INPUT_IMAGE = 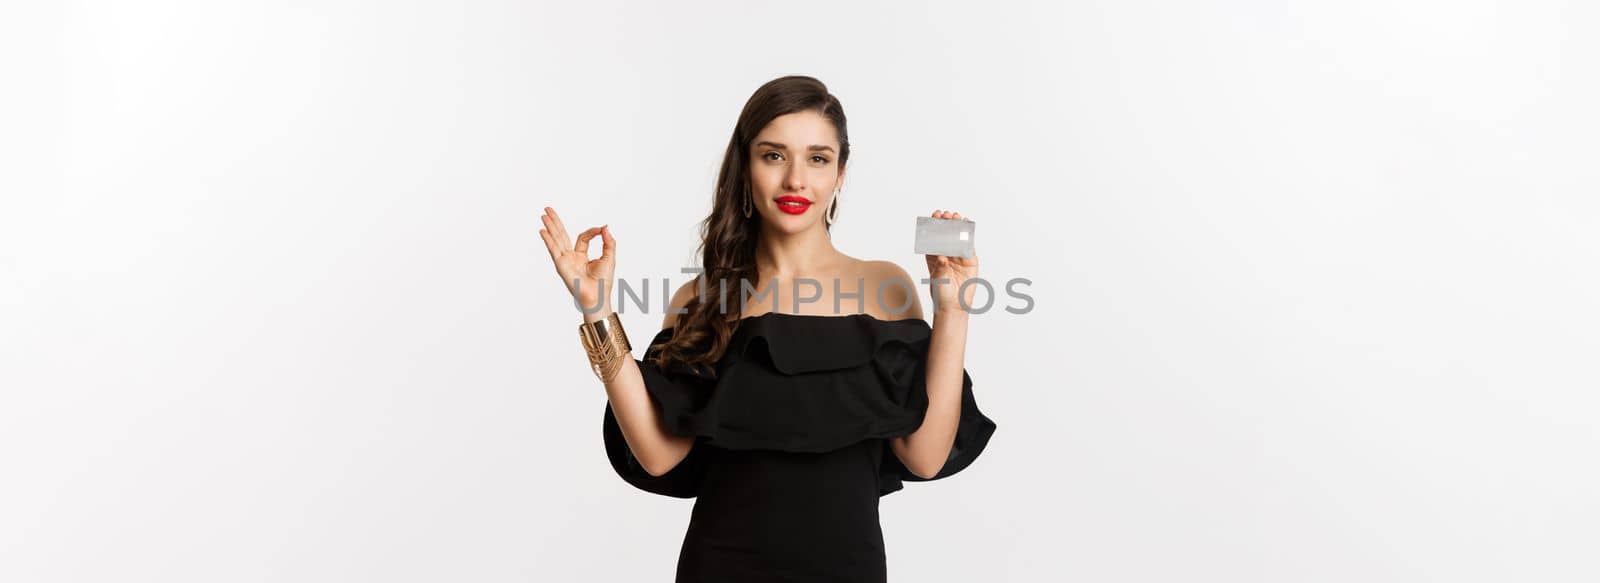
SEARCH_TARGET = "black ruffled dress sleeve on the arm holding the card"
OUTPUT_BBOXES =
[874,330,995,495]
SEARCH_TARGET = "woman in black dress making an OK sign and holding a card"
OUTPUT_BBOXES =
[539,77,995,583]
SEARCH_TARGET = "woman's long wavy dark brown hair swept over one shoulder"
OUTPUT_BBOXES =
[654,75,850,376]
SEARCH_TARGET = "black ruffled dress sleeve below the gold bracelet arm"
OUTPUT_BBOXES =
[602,328,714,498]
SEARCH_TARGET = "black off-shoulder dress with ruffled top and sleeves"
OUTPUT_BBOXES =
[603,312,995,583]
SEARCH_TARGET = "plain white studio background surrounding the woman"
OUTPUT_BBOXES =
[0,2,1600,581]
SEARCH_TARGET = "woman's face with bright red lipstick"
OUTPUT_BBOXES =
[749,111,845,232]
